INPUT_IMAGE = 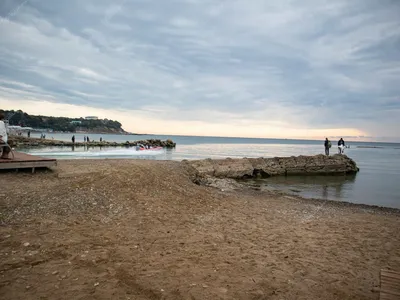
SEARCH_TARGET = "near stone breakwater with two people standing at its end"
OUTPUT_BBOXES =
[184,154,359,183]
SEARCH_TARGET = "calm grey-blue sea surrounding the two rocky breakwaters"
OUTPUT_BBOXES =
[21,134,400,208]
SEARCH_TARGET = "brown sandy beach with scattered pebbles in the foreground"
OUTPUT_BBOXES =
[0,160,400,300]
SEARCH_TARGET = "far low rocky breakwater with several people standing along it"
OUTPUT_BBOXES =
[10,136,176,149]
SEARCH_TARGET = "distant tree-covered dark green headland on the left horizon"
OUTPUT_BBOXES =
[5,110,126,133]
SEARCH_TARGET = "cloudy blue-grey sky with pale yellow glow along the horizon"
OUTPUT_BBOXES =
[0,0,400,140]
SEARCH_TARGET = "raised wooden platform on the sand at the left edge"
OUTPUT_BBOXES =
[0,151,57,173]
